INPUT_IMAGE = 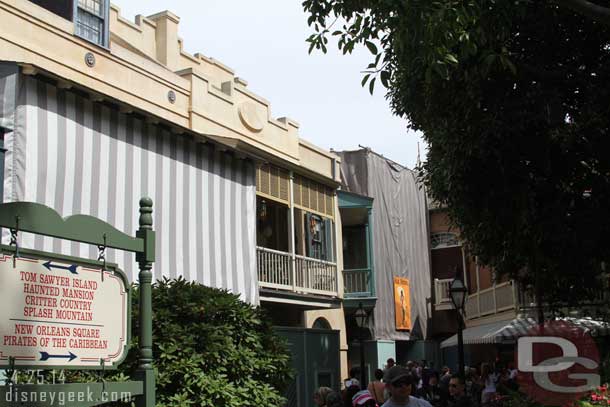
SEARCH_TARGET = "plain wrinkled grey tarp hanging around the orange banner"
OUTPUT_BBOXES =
[338,149,431,340]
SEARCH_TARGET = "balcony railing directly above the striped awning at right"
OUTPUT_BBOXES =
[466,281,516,319]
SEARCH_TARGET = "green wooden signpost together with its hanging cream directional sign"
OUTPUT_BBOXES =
[0,198,155,407]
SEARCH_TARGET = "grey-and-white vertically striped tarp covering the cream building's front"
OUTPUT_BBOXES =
[0,64,258,304]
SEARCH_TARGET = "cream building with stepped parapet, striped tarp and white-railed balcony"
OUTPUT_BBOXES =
[0,0,346,402]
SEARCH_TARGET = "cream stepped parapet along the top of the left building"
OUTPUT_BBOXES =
[0,0,339,183]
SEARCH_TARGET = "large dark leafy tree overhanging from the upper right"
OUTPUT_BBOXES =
[303,0,610,310]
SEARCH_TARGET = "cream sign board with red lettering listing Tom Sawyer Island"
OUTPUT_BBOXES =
[0,254,130,368]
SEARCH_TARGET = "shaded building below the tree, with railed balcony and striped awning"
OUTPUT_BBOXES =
[430,205,610,369]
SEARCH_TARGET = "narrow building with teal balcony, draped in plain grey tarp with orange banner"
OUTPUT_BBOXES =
[337,148,431,377]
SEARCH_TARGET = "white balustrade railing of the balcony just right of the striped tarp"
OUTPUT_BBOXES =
[256,247,338,297]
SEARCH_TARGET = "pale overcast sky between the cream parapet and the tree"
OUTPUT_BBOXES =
[113,0,425,168]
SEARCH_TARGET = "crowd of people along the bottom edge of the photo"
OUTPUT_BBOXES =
[314,358,518,407]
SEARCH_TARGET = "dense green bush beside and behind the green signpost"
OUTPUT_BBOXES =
[69,278,293,407]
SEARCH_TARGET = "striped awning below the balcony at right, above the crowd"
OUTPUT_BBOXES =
[441,318,610,348]
